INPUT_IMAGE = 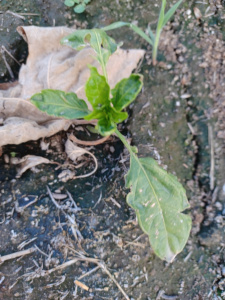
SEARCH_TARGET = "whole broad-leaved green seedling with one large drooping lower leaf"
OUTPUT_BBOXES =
[31,29,191,262]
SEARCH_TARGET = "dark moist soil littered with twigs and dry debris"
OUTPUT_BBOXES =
[0,0,225,300]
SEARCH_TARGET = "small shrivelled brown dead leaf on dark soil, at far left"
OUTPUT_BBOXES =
[11,155,55,178]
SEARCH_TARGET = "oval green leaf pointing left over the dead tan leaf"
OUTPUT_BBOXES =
[31,89,90,119]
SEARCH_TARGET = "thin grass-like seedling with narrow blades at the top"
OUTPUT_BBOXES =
[102,0,183,65]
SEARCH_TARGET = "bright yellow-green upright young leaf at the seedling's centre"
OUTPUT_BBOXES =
[85,67,110,108]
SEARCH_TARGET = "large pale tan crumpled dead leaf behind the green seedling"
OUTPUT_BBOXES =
[0,26,145,147]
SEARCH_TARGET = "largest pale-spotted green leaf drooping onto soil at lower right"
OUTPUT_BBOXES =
[126,156,191,262]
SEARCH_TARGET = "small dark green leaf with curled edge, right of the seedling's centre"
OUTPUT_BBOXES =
[111,74,143,111]
